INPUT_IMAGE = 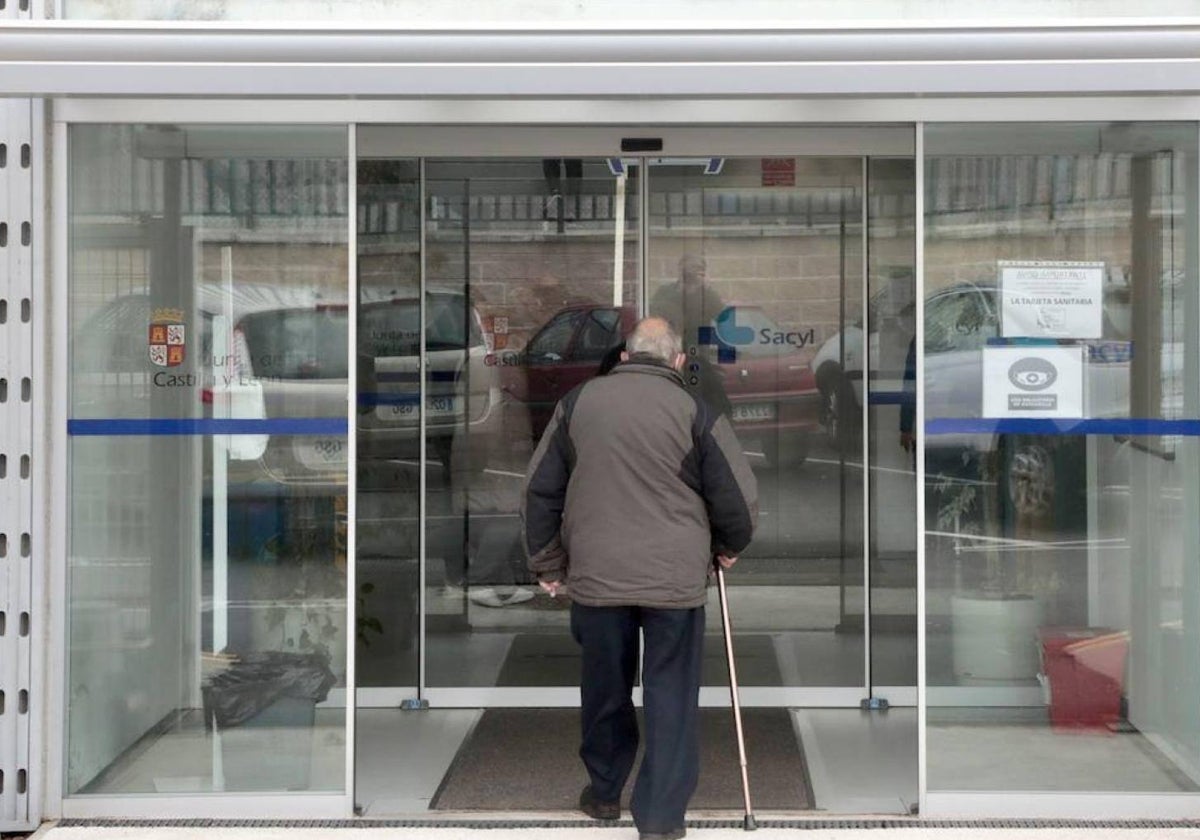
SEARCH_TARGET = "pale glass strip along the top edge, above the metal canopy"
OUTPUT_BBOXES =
[64,0,1195,25]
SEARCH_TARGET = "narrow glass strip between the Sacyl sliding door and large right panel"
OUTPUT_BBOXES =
[866,158,917,691]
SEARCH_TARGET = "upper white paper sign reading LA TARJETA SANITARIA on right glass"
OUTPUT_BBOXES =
[1000,260,1104,338]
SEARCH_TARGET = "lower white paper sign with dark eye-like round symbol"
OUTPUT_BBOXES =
[983,347,1084,418]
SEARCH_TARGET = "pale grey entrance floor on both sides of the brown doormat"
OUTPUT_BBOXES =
[72,708,1200,817]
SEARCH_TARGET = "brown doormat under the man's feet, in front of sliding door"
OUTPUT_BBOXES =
[430,708,812,814]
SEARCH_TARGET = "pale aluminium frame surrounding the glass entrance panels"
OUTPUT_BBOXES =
[49,98,1200,818]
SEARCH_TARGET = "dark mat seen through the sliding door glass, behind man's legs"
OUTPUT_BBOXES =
[496,630,782,686]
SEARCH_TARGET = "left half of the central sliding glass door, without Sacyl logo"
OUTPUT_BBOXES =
[358,158,641,706]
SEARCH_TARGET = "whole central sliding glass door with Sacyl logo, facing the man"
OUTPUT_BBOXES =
[358,132,916,706]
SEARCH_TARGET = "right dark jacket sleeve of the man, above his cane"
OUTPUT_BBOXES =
[697,412,758,556]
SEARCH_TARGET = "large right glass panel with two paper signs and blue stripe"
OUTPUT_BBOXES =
[924,124,1200,792]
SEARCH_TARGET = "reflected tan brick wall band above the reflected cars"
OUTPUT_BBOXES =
[208,219,1132,349]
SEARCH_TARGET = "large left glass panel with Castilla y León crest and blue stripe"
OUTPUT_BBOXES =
[66,126,348,794]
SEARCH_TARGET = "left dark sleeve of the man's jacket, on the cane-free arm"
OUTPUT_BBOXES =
[521,394,575,581]
